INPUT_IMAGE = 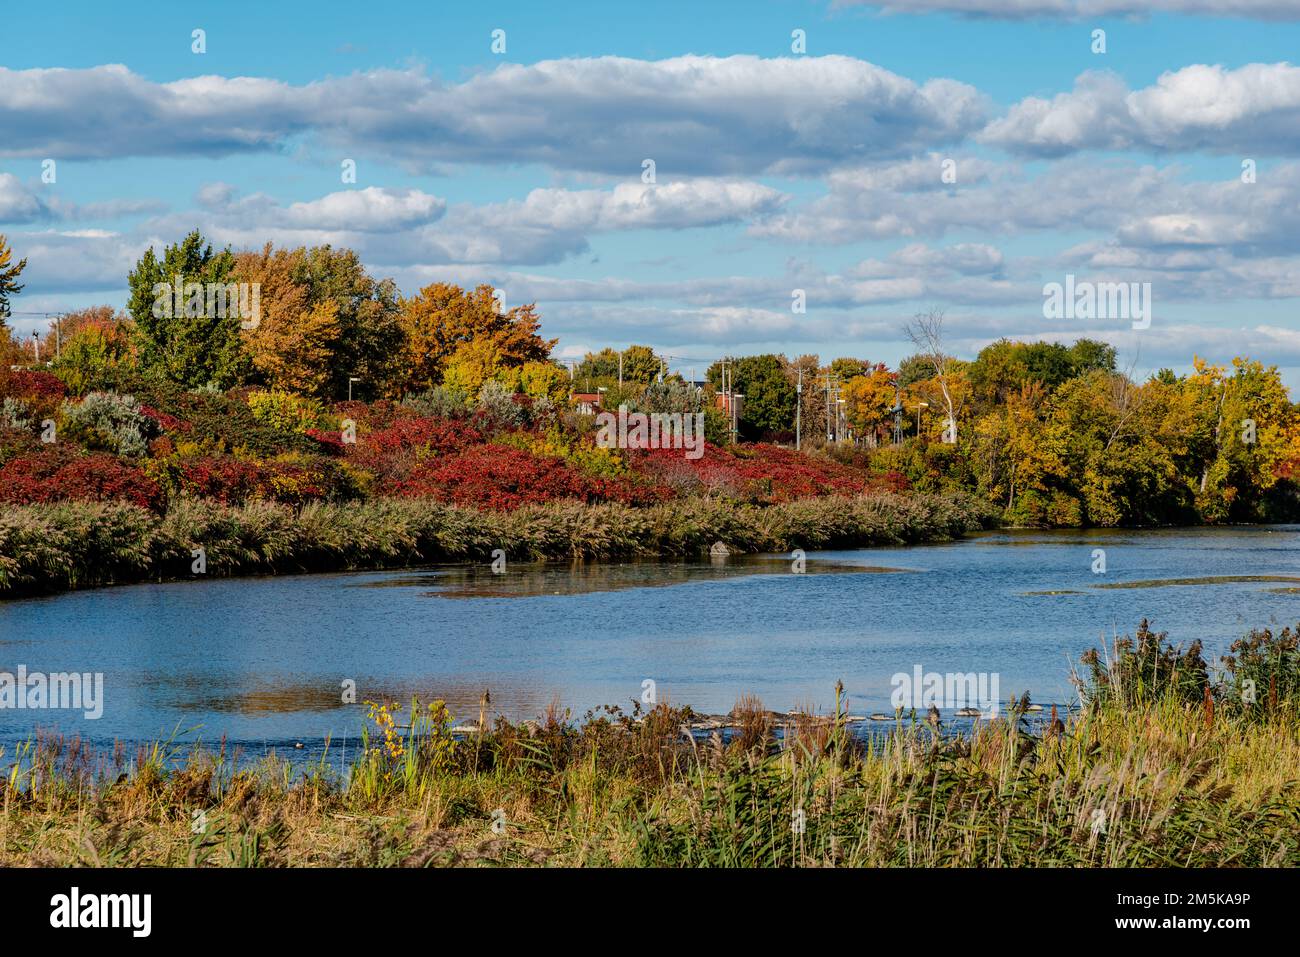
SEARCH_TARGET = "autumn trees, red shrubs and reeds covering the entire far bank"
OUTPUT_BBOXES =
[0,231,1300,594]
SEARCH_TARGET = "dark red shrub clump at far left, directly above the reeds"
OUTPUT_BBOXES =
[0,450,164,510]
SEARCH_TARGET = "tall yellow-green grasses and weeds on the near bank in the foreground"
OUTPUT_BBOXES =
[0,622,1300,867]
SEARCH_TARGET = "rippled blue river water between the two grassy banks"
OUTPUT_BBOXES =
[0,525,1300,752]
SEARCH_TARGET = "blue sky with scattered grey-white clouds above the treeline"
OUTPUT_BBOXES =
[0,0,1300,386]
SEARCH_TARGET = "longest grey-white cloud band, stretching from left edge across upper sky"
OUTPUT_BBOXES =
[0,56,987,177]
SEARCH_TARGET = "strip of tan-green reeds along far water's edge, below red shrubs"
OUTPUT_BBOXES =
[0,494,993,597]
